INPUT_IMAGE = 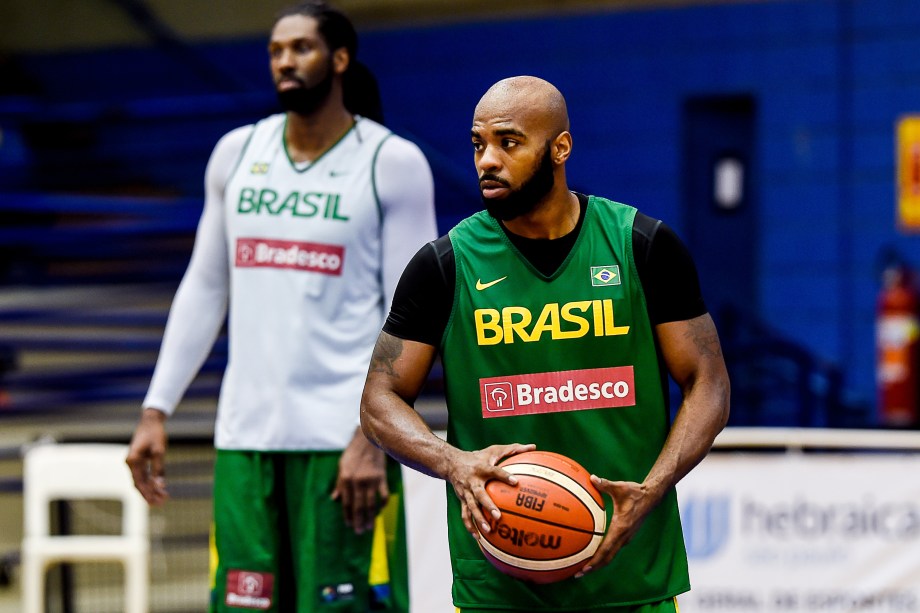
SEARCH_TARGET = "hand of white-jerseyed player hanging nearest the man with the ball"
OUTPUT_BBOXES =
[332,429,390,534]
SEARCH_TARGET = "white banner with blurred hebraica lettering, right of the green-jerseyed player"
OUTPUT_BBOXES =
[677,453,920,613]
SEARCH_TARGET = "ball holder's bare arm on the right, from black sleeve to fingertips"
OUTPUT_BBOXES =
[585,314,729,572]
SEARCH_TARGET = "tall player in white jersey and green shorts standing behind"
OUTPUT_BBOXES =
[128,2,437,613]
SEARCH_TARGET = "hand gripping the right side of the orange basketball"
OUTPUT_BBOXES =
[575,475,658,577]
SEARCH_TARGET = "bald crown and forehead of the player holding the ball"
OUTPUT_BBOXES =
[473,76,569,139]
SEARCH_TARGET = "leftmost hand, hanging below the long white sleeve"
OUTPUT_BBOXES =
[125,409,169,505]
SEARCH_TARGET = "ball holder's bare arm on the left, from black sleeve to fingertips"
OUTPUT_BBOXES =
[361,332,533,537]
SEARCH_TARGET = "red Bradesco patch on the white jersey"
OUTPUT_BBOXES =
[236,238,345,276]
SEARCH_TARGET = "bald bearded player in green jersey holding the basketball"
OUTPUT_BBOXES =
[361,77,729,613]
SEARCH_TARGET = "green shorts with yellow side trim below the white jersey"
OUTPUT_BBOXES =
[210,450,409,613]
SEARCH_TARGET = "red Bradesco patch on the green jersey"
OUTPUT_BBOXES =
[479,366,636,417]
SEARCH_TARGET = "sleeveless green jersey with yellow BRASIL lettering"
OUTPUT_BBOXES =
[441,196,690,611]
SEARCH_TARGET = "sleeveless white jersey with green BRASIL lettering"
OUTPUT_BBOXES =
[215,114,398,450]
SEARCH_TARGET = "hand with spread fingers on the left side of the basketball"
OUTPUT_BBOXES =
[447,443,537,539]
